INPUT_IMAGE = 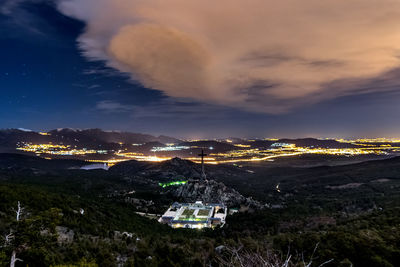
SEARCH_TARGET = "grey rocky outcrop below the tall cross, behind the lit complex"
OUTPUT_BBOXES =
[169,180,262,208]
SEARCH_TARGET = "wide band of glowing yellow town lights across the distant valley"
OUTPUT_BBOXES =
[16,138,400,166]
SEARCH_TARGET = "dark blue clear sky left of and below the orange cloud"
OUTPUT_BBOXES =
[0,2,400,138]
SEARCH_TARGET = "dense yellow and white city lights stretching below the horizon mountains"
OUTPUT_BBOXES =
[17,138,400,165]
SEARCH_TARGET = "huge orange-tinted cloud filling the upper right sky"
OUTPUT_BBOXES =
[58,0,400,113]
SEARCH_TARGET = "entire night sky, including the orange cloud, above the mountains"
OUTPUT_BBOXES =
[0,0,400,138]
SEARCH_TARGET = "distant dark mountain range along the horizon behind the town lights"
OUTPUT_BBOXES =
[0,128,354,150]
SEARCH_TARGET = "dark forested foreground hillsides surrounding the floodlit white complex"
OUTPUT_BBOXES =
[0,154,400,267]
